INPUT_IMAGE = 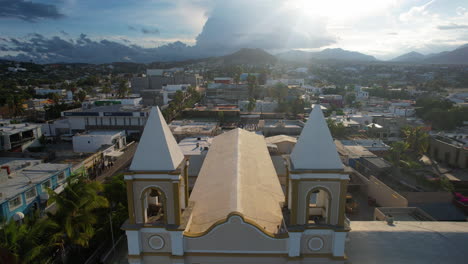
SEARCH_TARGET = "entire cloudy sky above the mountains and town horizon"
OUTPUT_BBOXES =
[0,0,468,61]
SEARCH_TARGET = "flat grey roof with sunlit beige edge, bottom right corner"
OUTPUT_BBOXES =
[345,221,468,264]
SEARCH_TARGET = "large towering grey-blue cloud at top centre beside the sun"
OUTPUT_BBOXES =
[196,0,336,53]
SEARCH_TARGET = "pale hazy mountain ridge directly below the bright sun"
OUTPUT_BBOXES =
[276,48,377,62]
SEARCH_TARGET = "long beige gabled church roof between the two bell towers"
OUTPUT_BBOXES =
[185,129,284,234]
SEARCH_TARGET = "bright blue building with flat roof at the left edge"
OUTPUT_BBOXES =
[0,158,71,220]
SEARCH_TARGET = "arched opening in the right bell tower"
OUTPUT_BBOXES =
[307,188,331,224]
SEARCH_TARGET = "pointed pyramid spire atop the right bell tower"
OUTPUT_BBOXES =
[291,104,343,170]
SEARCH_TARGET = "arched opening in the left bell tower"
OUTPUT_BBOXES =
[142,187,167,225]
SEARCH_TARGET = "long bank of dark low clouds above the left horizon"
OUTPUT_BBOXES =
[0,33,199,63]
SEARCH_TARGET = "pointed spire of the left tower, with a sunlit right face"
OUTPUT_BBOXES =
[130,107,184,171]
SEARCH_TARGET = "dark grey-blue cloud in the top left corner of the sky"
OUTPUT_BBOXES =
[0,0,64,22]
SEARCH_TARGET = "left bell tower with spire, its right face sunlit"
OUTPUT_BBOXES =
[125,107,188,227]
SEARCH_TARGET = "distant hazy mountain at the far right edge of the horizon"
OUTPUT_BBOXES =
[391,44,468,64]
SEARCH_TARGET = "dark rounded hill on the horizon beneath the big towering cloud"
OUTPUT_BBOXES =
[215,48,278,65]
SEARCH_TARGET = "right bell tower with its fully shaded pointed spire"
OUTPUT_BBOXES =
[287,104,349,257]
